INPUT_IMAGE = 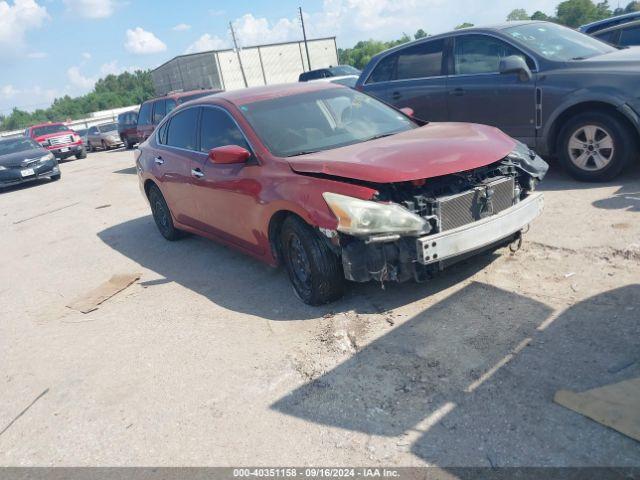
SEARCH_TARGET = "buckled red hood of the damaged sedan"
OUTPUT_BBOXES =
[287,123,516,183]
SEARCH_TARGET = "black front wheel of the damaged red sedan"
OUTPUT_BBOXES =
[280,216,345,306]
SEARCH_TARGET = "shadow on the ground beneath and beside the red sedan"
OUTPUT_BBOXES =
[98,216,497,320]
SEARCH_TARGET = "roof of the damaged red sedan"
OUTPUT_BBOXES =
[197,82,347,105]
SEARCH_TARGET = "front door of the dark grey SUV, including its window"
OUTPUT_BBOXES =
[447,34,536,142]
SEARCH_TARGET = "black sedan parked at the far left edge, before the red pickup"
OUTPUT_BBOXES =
[0,137,61,188]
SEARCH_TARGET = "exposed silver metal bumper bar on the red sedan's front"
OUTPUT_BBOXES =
[417,193,544,265]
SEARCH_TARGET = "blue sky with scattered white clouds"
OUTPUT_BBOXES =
[0,0,559,114]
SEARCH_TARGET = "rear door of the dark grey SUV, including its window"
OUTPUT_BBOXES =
[364,39,448,121]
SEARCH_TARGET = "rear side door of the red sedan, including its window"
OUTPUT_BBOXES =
[153,107,200,228]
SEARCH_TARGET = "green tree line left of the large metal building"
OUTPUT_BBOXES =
[0,70,154,131]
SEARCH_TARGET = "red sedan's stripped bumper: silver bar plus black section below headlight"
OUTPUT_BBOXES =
[341,193,544,282]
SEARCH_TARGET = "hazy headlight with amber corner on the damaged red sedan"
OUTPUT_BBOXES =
[322,192,427,235]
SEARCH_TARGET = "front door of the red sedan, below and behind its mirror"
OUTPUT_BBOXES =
[192,105,263,253]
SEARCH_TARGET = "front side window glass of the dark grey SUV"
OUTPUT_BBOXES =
[453,35,535,75]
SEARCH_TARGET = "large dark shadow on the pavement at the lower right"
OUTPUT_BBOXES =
[272,283,640,467]
